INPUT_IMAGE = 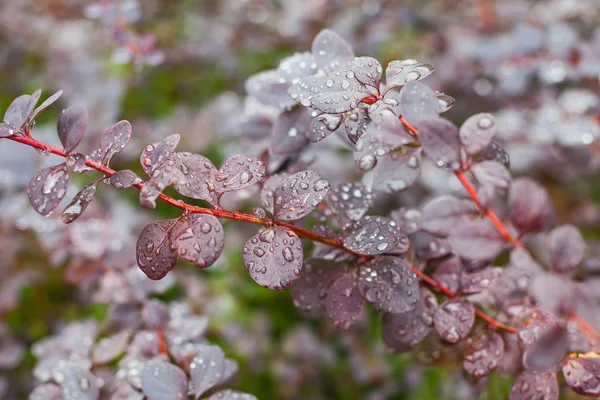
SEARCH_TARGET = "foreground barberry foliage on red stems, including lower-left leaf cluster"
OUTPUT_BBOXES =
[0,30,600,400]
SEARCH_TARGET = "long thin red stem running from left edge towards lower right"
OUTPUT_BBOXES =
[9,135,516,333]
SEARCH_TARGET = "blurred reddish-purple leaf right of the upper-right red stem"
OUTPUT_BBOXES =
[508,178,554,234]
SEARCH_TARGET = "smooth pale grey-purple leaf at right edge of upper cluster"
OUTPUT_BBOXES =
[398,82,439,125]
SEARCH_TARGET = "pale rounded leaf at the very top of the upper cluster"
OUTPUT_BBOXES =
[312,29,354,71]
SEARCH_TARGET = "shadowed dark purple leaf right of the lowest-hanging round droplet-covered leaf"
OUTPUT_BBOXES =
[290,258,344,313]
